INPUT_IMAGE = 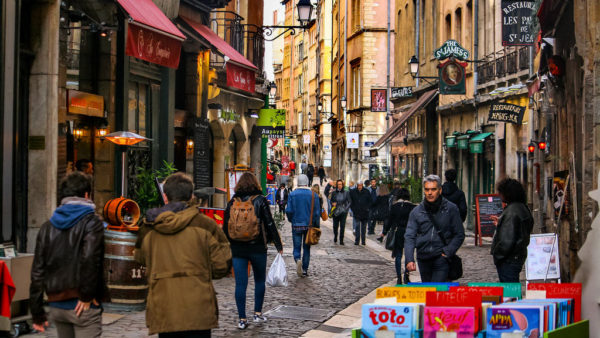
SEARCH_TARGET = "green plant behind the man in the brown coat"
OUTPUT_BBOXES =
[134,161,177,215]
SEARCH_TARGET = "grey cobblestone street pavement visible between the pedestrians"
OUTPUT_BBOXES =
[23,185,506,337]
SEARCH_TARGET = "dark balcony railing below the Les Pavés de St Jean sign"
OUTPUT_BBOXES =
[477,47,529,85]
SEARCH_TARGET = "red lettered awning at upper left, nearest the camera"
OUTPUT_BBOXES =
[117,0,185,68]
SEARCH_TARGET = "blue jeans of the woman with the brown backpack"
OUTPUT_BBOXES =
[233,252,267,319]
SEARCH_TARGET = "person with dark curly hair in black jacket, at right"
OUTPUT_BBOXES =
[491,178,533,283]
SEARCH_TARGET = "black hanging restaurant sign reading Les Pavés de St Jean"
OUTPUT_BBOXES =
[500,0,537,46]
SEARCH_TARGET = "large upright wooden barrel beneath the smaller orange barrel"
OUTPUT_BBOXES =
[104,230,148,310]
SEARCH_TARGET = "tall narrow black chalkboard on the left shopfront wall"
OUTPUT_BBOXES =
[194,118,212,188]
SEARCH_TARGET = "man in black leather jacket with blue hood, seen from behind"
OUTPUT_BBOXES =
[29,172,107,337]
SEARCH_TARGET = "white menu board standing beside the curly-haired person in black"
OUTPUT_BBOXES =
[525,233,560,280]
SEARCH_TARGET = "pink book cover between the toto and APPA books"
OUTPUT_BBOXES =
[423,306,477,338]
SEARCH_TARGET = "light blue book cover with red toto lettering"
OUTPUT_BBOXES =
[361,304,416,338]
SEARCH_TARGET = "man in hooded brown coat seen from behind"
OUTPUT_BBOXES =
[135,173,231,337]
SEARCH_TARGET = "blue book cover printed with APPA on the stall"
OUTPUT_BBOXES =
[486,304,544,338]
